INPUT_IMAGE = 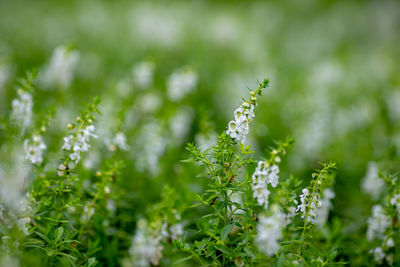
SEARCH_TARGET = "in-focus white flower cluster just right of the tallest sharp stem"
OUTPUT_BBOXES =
[252,161,279,209]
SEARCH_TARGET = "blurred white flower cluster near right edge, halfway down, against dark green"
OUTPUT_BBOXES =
[361,162,385,199]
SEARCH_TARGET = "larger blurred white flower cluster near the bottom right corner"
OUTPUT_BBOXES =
[367,205,391,241]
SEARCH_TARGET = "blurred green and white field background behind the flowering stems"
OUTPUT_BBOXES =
[0,0,400,264]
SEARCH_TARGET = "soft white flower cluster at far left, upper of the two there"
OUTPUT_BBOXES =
[11,90,33,131]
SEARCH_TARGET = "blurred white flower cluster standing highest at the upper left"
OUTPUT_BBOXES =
[39,46,80,89]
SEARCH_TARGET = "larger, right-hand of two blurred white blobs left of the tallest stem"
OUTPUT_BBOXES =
[167,69,198,102]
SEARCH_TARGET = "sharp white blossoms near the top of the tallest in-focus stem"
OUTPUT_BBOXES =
[226,102,254,144]
